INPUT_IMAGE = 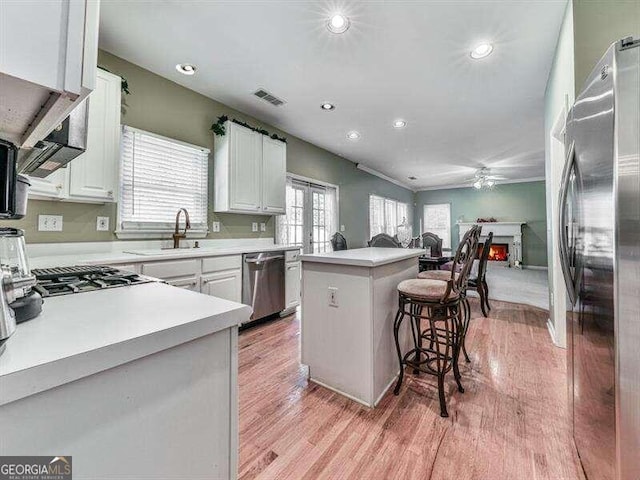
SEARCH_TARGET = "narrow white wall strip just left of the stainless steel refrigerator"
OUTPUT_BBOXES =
[544,0,575,348]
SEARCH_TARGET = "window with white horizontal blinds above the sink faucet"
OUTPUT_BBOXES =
[118,126,209,234]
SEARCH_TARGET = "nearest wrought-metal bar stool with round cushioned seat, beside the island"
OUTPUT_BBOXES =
[393,227,476,417]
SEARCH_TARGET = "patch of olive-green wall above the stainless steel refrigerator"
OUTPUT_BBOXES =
[573,0,640,93]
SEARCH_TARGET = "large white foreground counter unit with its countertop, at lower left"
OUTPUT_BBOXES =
[0,282,251,479]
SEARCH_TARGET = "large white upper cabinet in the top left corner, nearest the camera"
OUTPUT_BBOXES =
[0,0,100,148]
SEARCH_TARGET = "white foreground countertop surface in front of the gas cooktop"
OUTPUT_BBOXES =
[0,283,251,405]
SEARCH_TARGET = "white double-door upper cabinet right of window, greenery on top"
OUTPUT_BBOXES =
[214,122,287,215]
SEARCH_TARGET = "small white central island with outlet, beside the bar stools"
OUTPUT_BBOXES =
[300,248,424,407]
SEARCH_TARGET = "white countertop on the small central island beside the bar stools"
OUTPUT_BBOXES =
[300,247,425,267]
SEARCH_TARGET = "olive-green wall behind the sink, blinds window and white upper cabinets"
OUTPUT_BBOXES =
[7,51,413,247]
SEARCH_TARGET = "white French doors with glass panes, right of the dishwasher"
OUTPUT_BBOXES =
[276,175,338,253]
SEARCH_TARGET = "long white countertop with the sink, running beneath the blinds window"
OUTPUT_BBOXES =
[29,244,300,268]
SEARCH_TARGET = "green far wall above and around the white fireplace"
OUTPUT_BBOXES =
[414,181,547,267]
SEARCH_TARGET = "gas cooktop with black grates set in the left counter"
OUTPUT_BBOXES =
[31,265,158,297]
